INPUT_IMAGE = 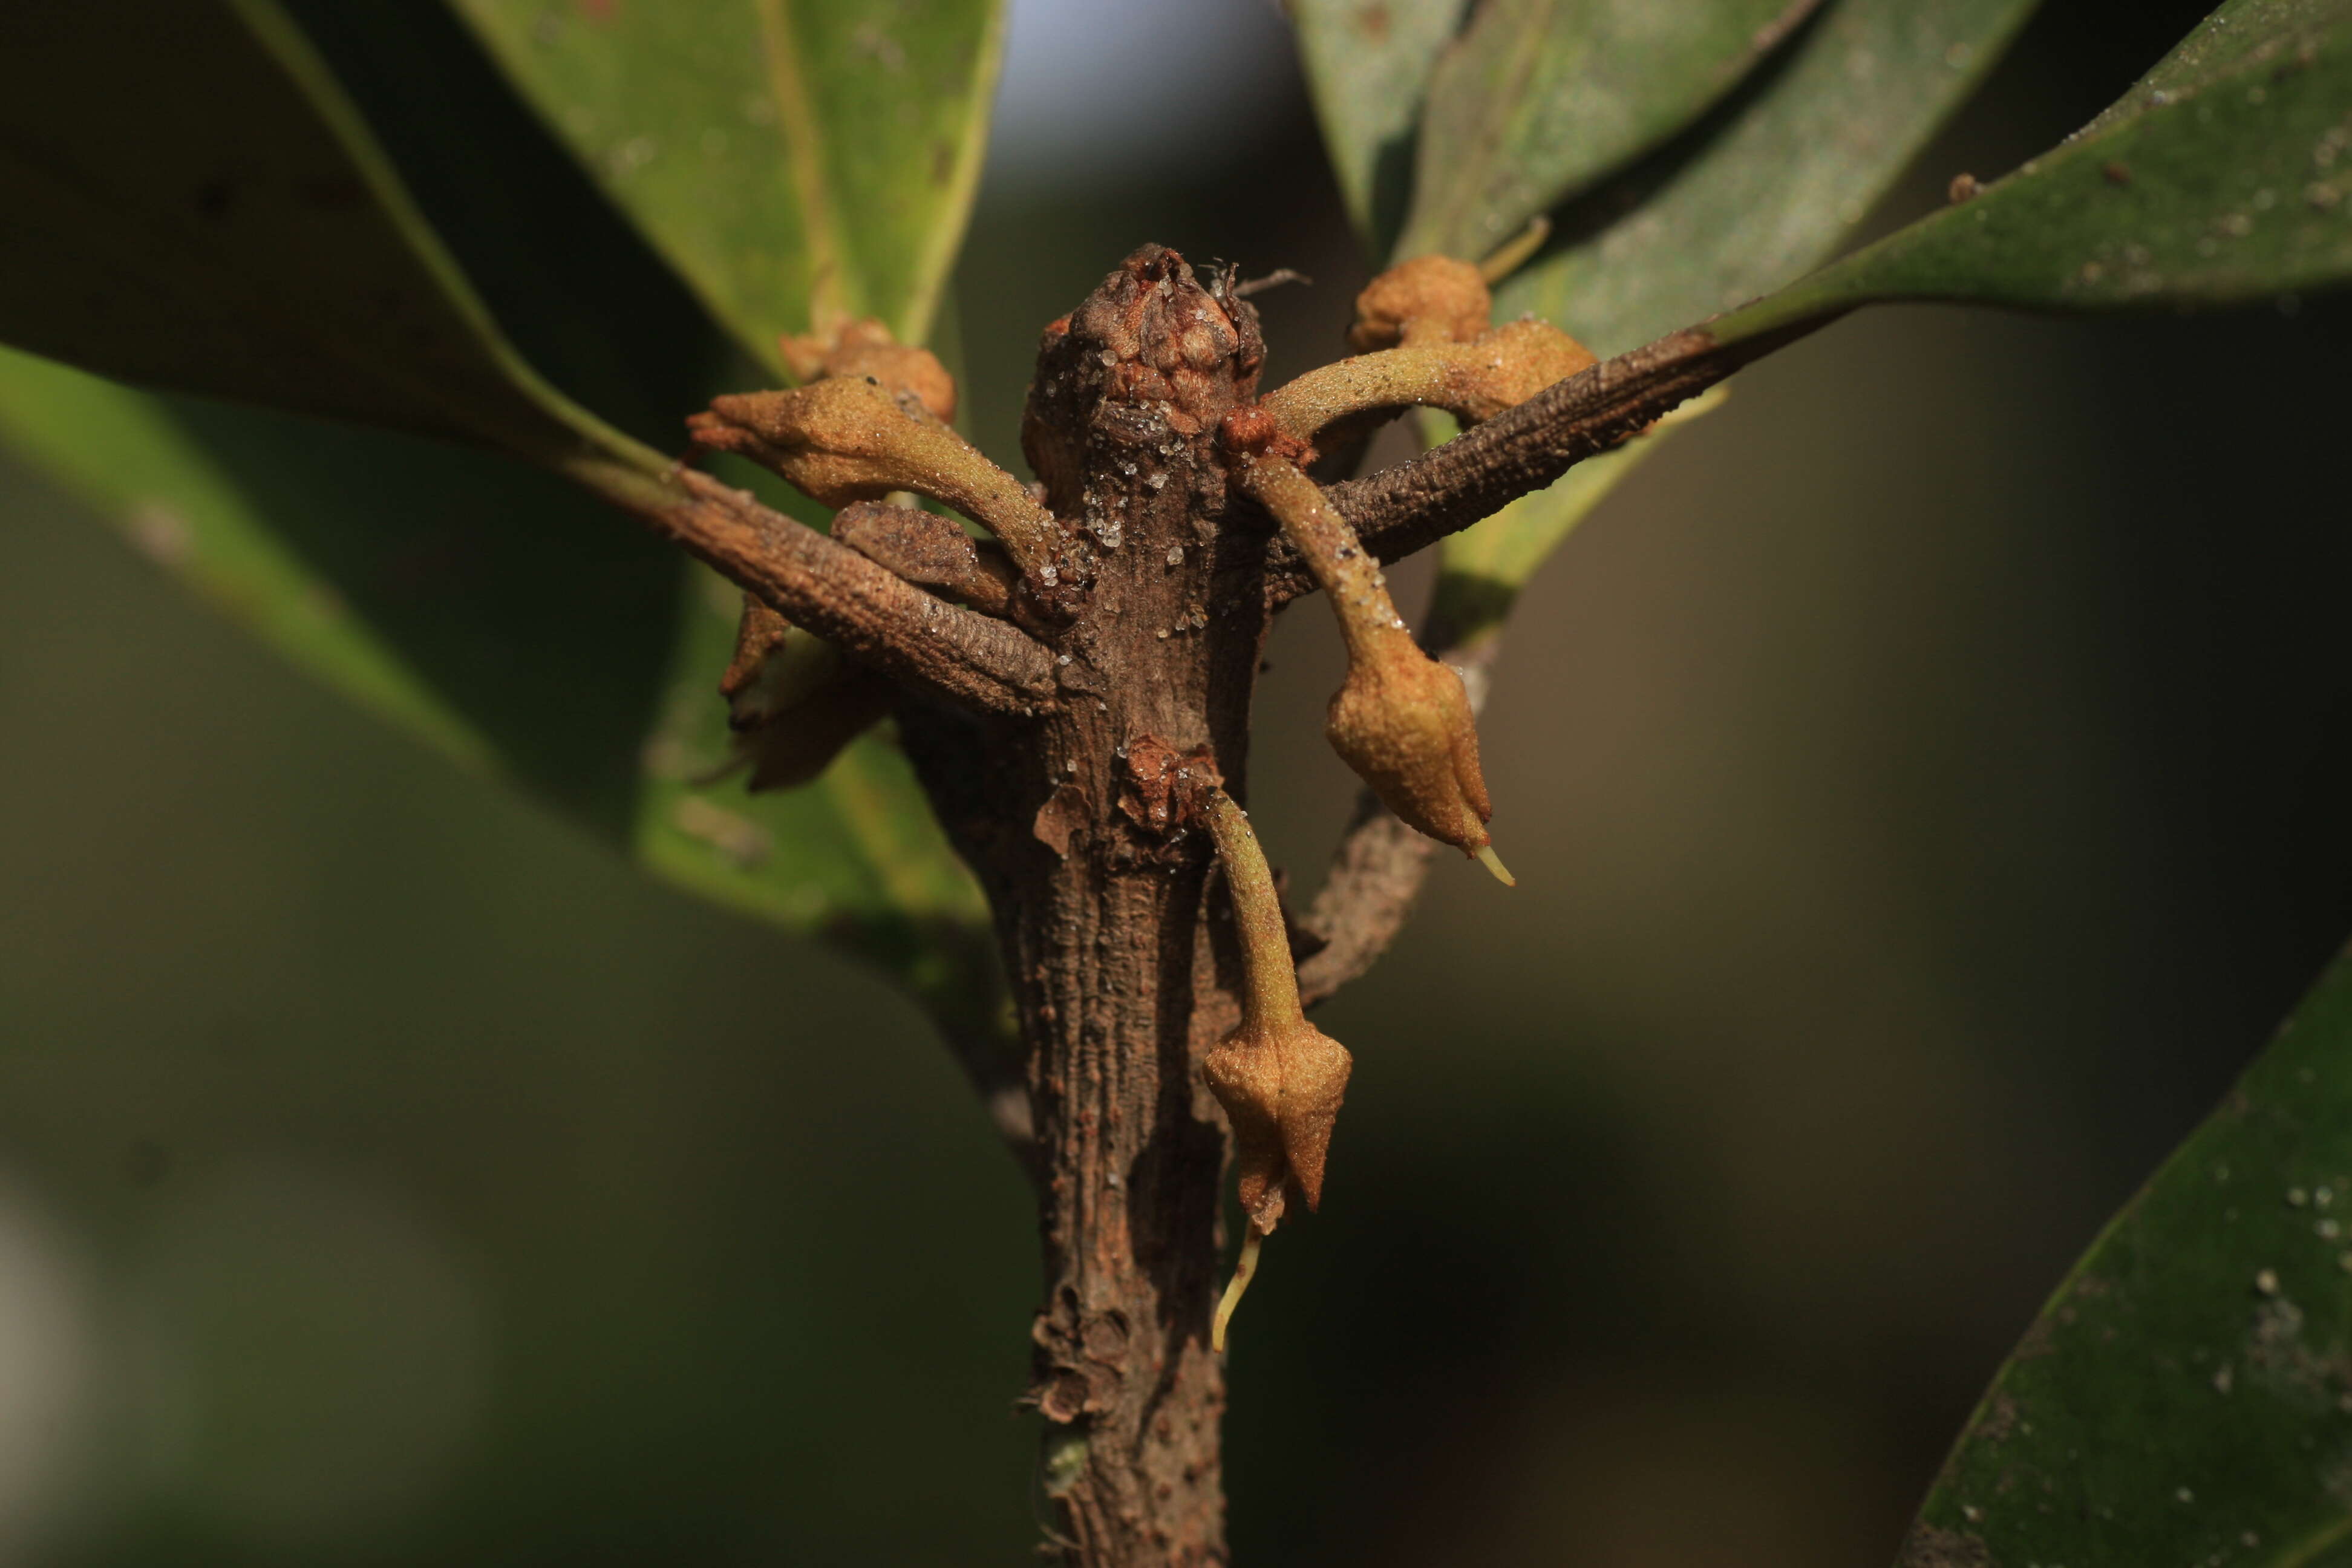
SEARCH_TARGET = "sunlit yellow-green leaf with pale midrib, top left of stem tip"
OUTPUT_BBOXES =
[454,0,1004,367]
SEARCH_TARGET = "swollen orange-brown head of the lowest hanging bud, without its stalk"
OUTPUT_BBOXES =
[1202,1011,1354,1232]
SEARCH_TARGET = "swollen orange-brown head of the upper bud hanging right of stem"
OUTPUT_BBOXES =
[1324,637,1494,856]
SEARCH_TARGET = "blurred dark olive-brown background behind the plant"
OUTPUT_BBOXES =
[0,0,2352,1568]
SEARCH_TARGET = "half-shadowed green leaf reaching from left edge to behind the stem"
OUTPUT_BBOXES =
[0,350,993,1032]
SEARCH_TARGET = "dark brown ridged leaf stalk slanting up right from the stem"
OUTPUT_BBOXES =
[1266,318,1835,604]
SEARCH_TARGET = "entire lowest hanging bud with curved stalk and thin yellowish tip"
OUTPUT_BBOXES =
[1202,790,1353,1350]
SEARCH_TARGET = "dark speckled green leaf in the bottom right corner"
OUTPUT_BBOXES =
[1901,940,2352,1568]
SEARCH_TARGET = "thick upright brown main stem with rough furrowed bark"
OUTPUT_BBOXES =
[901,247,1270,1568]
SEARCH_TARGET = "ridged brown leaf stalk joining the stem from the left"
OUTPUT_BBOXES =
[633,468,1054,714]
